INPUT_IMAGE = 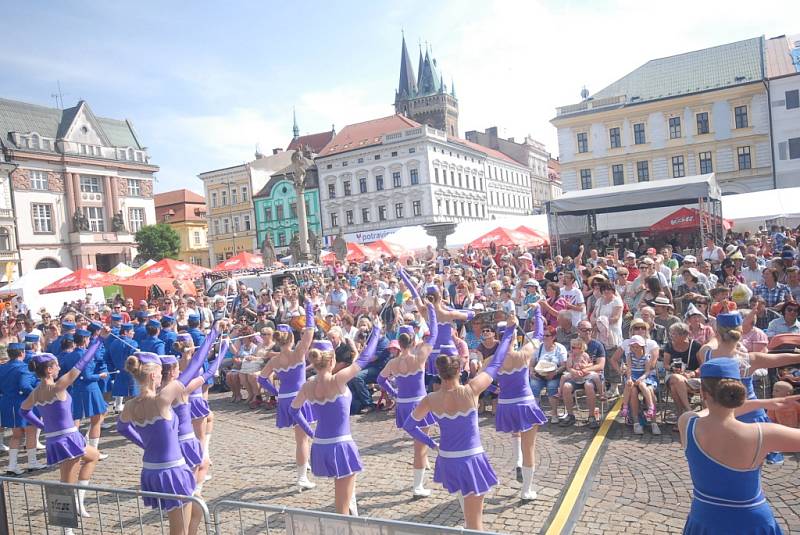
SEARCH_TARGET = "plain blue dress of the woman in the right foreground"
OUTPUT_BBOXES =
[683,416,783,535]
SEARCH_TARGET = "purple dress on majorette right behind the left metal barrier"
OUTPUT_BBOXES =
[131,414,196,511]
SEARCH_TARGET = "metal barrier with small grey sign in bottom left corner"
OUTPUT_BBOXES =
[0,477,214,535]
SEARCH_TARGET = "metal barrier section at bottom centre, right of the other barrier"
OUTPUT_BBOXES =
[211,500,490,535]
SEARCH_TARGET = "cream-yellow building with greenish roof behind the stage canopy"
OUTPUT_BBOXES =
[551,37,773,193]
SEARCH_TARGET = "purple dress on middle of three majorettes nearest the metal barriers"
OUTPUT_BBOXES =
[310,388,364,479]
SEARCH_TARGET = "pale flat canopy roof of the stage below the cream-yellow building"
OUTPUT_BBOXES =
[547,173,722,215]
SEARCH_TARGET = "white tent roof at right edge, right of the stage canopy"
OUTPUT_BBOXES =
[722,187,800,232]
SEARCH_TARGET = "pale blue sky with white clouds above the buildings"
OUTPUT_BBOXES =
[0,0,800,193]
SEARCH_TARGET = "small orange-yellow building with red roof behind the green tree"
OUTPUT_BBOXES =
[155,189,209,267]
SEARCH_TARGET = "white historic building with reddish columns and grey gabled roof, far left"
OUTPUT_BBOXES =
[0,99,158,272]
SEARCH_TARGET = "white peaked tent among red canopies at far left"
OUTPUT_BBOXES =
[0,267,103,319]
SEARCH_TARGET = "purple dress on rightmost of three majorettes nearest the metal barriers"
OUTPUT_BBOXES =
[433,408,497,496]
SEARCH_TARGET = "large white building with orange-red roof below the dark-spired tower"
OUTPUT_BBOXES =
[316,115,532,242]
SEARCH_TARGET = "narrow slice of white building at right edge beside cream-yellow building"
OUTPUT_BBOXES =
[766,34,800,188]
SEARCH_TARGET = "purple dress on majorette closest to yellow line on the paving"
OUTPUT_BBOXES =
[495,366,547,433]
